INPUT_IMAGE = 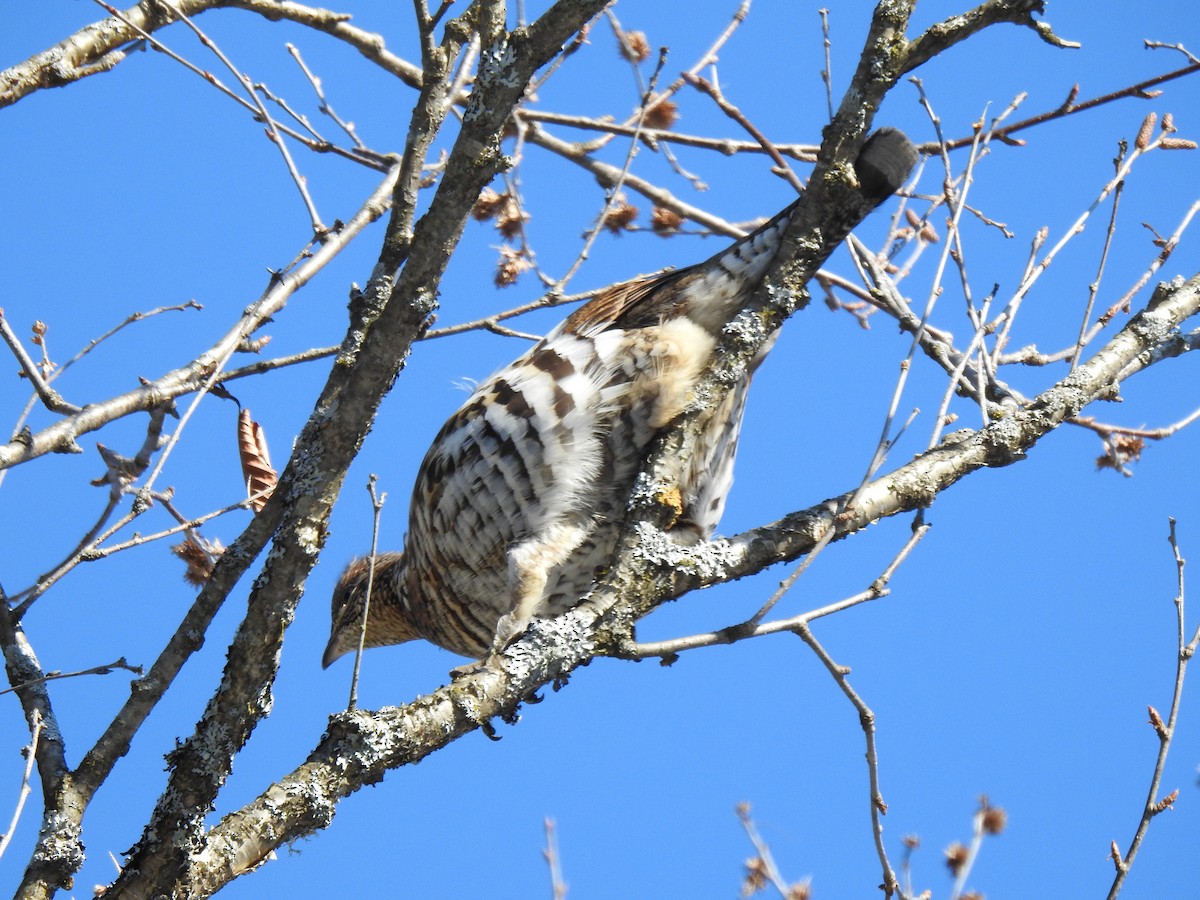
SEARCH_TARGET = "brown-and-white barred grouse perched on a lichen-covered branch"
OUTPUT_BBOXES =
[323,128,918,668]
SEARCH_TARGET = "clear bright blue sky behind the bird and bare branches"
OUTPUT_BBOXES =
[0,0,1200,900]
